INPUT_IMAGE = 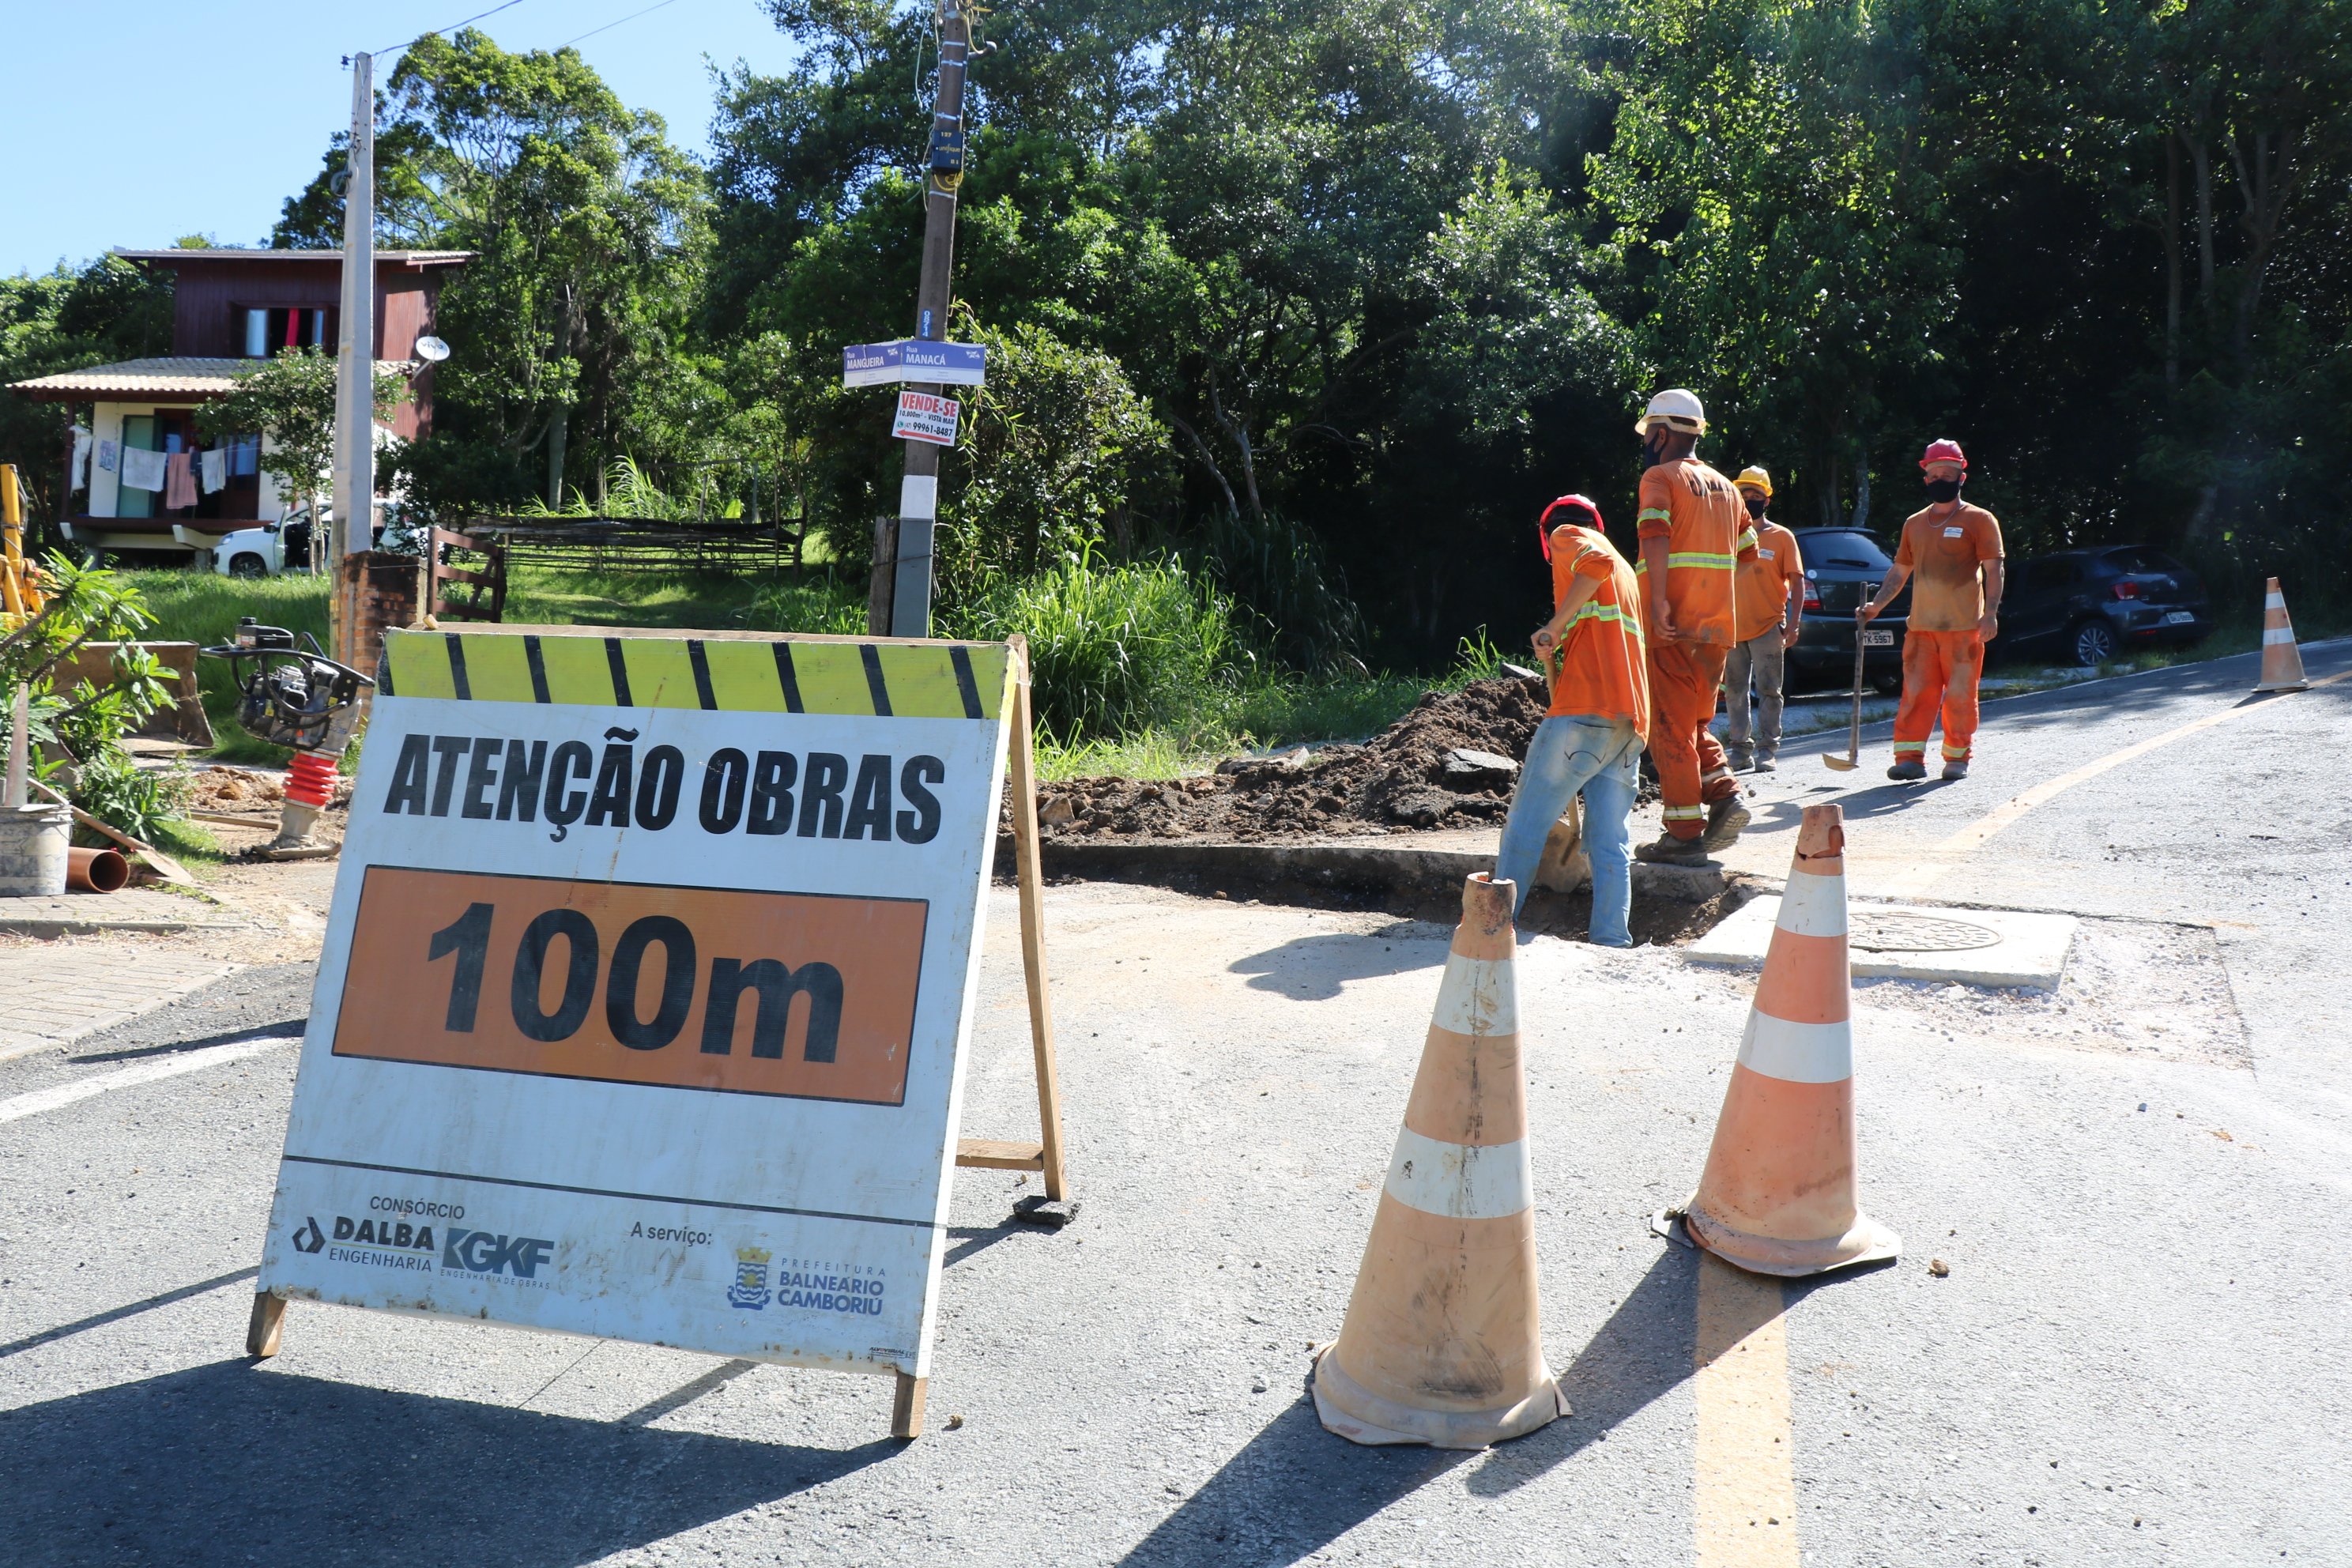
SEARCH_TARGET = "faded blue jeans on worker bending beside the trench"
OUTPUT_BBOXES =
[1494,717,1642,948]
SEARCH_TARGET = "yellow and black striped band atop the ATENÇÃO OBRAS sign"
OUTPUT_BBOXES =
[376,628,1012,719]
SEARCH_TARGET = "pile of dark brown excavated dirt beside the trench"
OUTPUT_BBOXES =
[1037,677,1656,844]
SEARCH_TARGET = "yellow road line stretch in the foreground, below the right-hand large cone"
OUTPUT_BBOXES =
[1691,1253,1797,1568]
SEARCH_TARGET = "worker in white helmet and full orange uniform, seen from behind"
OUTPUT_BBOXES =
[1634,388,1755,865]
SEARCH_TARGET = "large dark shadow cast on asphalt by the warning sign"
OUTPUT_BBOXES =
[0,1361,903,1568]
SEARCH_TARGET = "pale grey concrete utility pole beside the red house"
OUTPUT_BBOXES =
[331,54,376,663]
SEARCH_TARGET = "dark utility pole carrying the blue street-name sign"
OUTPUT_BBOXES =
[865,0,974,637]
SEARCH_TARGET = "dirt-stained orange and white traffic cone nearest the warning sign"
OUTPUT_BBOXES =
[1315,873,1569,1448]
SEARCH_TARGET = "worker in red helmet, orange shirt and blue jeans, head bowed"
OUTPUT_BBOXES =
[1494,496,1649,948]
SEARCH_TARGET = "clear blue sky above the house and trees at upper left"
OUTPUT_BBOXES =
[0,0,793,273]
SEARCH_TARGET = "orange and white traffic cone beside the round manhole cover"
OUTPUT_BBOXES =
[1682,806,1903,1274]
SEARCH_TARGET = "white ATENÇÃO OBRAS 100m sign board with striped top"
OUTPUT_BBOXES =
[261,628,1012,1378]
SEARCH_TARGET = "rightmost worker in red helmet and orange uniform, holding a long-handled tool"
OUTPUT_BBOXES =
[1853,439,2002,778]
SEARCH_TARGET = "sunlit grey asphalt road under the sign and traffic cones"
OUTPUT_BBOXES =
[0,646,2352,1568]
